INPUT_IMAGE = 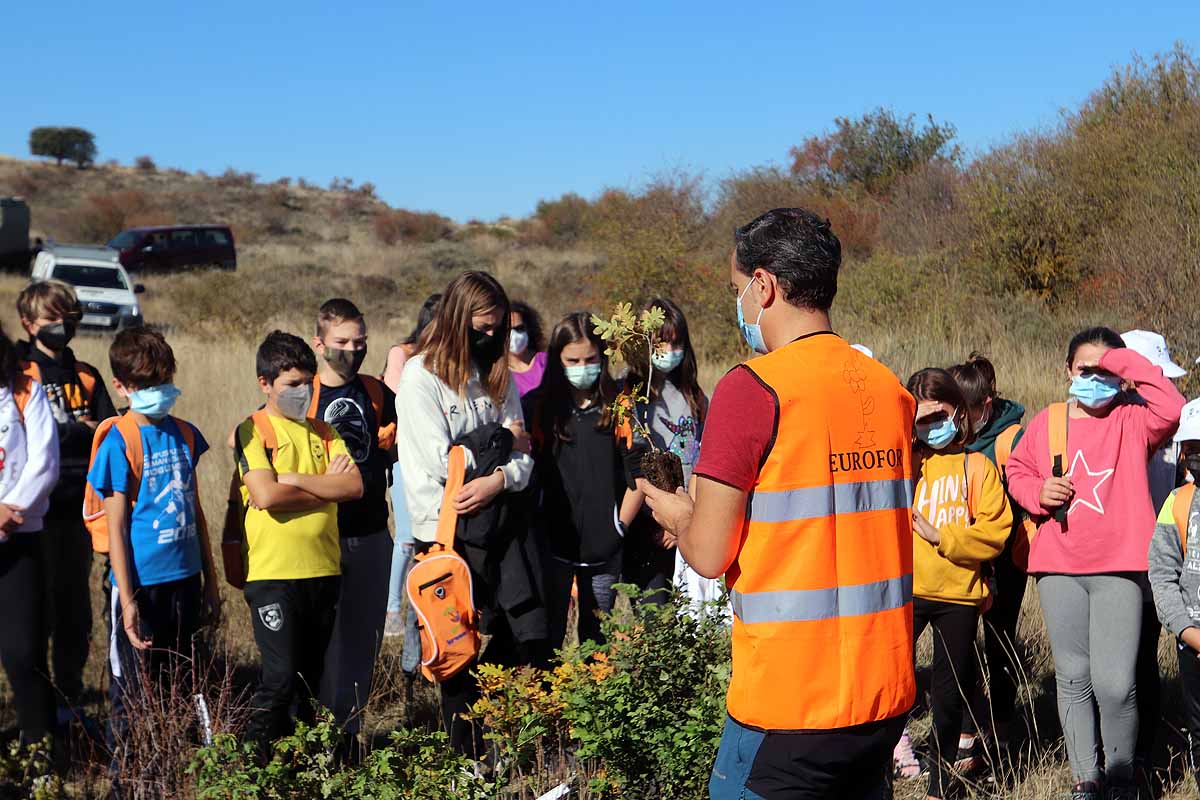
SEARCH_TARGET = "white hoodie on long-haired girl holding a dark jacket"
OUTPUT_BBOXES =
[396,355,533,542]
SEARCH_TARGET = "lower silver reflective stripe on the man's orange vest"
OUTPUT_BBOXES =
[730,575,912,625]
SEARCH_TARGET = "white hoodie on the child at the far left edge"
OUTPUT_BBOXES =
[0,380,59,533]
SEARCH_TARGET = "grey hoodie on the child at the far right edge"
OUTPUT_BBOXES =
[1150,489,1200,638]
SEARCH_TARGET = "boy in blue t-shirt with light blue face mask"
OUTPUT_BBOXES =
[88,327,221,764]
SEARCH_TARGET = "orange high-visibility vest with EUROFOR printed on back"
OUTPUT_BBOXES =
[726,335,917,730]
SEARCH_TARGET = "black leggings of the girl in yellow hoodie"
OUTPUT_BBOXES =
[912,597,979,798]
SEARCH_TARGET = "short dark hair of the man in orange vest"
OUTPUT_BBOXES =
[733,209,841,311]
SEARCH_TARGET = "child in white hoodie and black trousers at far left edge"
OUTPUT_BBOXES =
[0,330,59,744]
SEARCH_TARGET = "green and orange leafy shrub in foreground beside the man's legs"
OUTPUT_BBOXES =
[473,584,731,800]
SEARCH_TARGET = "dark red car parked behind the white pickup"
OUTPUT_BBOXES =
[108,225,238,272]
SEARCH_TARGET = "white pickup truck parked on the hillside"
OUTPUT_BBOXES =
[31,245,145,331]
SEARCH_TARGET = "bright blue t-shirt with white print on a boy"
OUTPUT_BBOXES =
[88,417,209,587]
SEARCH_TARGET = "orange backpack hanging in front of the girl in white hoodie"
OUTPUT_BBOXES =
[407,446,480,684]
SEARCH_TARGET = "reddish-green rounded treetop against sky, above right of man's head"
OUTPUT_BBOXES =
[791,108,960,196]
